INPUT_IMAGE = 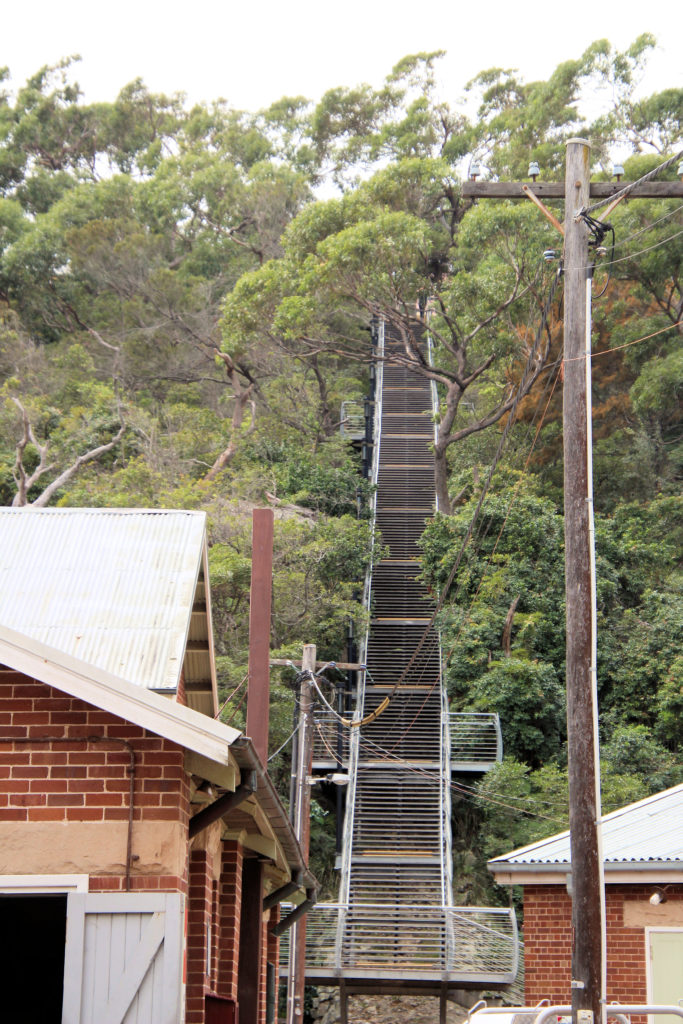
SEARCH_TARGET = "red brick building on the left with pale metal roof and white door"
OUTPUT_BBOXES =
[0,509,314,1024]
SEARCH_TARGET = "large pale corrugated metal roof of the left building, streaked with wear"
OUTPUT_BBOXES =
[0,508,206,691]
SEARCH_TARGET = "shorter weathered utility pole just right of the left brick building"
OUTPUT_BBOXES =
[287,644,315,1024]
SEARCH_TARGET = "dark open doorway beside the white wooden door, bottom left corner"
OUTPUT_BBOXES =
[0,893,67,1024]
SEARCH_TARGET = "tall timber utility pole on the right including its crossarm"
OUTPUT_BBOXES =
[463,138,683,1024]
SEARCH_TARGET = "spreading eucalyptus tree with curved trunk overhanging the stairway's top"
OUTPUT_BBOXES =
[222,159,550,512]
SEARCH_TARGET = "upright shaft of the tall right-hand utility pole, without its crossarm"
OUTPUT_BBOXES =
[563,138,604,1024]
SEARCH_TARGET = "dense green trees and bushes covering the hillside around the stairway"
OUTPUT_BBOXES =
[0,36,683,900]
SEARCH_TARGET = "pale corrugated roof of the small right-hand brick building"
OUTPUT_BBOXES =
[488,784,683,869]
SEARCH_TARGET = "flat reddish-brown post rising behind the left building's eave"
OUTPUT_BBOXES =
[247,509,273,764]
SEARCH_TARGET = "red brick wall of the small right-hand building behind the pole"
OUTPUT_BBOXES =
[524,885,683,1006]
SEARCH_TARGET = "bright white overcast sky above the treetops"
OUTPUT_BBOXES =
[0,0,683,111]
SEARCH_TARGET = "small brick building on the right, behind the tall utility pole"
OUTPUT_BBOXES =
[488,785,683,1020]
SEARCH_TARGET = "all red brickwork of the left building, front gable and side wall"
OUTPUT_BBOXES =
[0,668,286,1024]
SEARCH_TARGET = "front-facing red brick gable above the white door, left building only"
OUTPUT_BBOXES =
[0,669,189,891]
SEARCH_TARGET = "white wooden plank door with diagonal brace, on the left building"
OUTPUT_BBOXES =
[61,893,184,1024]
